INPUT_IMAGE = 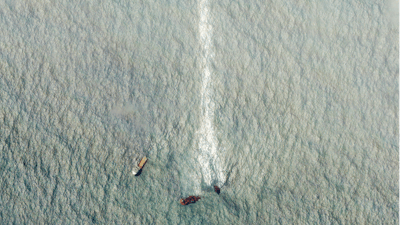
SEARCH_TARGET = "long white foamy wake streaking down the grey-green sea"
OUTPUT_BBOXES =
[198,0,225,185]
